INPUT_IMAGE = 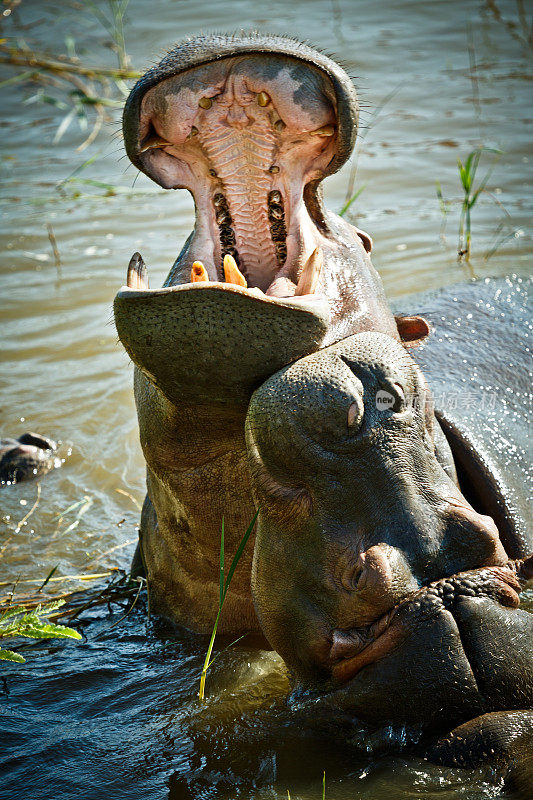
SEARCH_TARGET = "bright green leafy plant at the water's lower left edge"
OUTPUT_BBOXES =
[0,600,81,664]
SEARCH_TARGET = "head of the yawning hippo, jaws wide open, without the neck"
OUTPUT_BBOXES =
[115,34,424,404]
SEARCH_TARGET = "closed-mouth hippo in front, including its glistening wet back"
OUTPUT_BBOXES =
[246,279,533,785]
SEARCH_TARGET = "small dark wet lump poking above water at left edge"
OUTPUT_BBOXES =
[0,433,57,483]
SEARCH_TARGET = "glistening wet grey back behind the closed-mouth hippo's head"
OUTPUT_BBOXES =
[396,276,533,558]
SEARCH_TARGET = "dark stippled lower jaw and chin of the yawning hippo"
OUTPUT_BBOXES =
[114,283,329,407]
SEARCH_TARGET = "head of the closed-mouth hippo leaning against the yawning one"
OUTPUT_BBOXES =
[246,333,533,723]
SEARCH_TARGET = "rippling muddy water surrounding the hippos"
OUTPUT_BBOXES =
[0,0,533,800]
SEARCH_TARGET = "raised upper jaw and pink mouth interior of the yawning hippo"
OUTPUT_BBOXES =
[124,35,358,297]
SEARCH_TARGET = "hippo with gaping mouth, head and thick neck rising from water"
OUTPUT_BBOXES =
[115,35,428,632]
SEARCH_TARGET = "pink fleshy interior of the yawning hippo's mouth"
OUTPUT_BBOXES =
[140,55,337,296]
